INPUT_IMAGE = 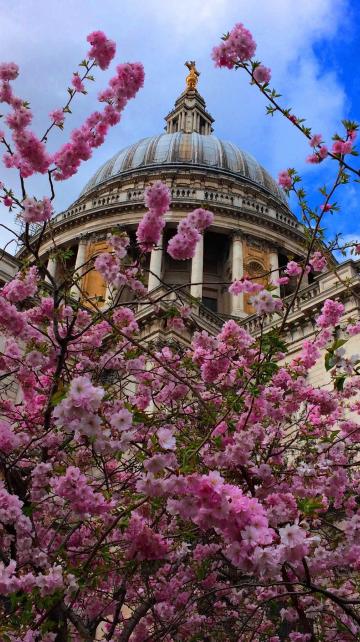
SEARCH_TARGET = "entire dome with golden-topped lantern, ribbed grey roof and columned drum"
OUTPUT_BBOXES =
[24,61,312,317]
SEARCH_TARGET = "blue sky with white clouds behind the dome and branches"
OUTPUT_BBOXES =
[0,0,360,251]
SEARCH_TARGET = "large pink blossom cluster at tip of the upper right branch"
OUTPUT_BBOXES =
[211,23,256,69]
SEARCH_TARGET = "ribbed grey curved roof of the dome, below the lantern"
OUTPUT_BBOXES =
[81,131,287,204]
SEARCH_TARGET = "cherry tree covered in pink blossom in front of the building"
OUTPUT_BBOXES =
[0,24,360,642]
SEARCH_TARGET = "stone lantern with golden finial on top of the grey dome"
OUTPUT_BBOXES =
[165,60,214,136]
